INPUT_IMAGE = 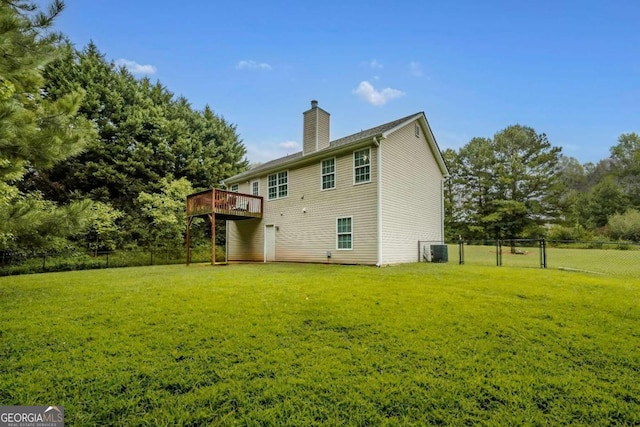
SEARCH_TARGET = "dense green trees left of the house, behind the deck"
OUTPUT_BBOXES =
[0,0,247,251]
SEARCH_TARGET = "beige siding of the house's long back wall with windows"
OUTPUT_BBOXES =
[228,147,377,264]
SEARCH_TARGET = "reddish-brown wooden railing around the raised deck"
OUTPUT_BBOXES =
[187,188,263,218]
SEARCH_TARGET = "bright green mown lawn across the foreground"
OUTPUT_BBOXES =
[0,263,640,426]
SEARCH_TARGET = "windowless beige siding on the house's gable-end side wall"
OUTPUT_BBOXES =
[382,118,443,264]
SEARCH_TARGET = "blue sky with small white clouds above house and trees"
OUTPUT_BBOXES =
[57,0,640,163]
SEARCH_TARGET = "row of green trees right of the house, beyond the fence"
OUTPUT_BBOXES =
[443,125,640,242]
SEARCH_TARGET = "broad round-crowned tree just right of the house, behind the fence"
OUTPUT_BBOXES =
[447,125,561,239]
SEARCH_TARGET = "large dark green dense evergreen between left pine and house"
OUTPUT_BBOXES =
[24,43,247,249]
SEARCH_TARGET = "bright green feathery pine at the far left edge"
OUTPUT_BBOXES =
[0,0,95,248]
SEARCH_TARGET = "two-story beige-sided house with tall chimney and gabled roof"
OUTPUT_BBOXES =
[209,101,447,266]
